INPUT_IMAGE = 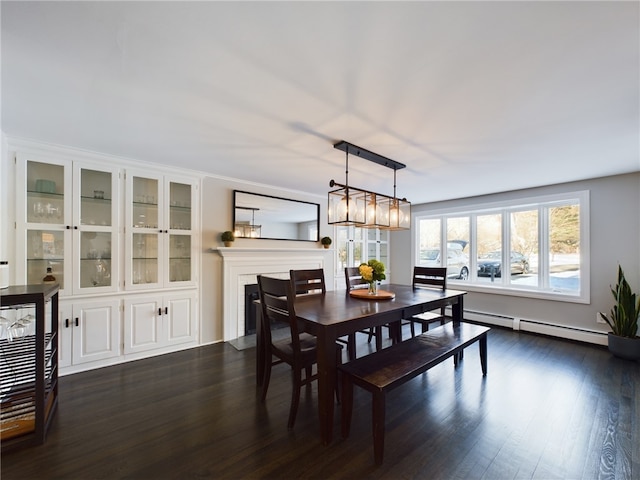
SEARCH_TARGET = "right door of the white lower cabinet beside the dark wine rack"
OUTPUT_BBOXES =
[73,300,120,364]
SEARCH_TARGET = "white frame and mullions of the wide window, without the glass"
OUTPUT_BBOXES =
[412,190,591,304]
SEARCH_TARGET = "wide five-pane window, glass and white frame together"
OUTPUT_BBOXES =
[415,192,589,303]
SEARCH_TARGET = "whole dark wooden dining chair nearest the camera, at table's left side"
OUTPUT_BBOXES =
[258,275,342,430]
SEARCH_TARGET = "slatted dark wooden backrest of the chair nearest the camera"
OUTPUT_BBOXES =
[258,275,300,353]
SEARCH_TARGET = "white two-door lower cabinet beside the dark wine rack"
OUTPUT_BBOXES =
[58,299,121,368]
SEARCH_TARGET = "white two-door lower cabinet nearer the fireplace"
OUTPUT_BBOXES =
[124,292,197,355]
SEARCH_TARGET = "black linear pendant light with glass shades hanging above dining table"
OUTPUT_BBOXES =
[328,140,411,230]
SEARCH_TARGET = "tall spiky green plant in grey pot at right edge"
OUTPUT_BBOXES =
[600,265,640,360]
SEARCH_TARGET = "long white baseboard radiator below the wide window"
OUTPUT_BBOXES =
[464,309,607,345]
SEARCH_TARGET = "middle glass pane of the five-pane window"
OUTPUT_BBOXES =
[476,213,502,283]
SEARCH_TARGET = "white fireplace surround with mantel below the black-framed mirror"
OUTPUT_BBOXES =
[215,247,332,342]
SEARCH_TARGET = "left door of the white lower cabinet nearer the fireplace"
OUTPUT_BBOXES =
[124,298,164,355]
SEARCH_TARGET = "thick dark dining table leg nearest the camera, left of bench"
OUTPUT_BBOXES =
[317,329,336,445]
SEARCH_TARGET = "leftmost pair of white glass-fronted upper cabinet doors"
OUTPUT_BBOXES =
[16,154,119,296]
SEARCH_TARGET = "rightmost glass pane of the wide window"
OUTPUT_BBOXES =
[549,205,580,292]
